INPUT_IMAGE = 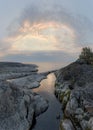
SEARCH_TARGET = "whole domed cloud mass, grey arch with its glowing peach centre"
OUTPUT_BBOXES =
[0,0,93,59]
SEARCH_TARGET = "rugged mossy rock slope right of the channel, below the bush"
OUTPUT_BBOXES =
[55,62,93,130]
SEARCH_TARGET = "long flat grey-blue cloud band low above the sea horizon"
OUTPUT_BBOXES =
[0,51,77,63]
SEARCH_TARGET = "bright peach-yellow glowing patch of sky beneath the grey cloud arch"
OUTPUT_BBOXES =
[12,21,79,52]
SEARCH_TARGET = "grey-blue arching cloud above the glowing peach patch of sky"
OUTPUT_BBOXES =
[6,0,93,45]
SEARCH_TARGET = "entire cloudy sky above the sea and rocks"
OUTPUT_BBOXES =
[0,0,93,62]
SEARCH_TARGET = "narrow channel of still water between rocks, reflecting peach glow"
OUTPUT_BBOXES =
[33,73,62,130]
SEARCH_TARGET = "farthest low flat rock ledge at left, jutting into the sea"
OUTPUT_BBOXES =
[0,62,38,81]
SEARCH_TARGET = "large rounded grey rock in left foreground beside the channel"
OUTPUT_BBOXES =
[0,82,48,130]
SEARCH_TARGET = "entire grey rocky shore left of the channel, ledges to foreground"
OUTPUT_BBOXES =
[0,62,48,130]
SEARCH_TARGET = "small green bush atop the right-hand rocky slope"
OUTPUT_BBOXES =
[79,47,93,65]
